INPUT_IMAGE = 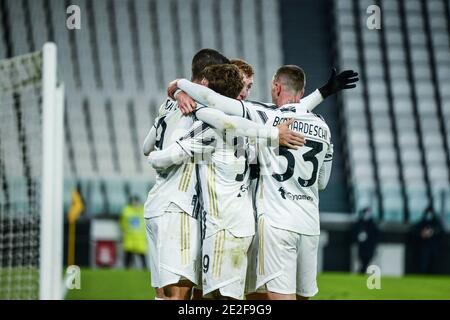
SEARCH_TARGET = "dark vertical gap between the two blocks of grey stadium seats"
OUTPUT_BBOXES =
[280,0,357,212]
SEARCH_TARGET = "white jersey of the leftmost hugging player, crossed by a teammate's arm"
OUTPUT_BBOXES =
[144,99,197,218]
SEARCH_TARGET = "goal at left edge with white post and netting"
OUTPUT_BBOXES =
[0,43,63,299]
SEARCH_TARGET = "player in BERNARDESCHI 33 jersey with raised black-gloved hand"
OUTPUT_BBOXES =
[169,66,358,299]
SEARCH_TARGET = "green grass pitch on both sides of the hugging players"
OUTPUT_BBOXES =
[66,269,450,300]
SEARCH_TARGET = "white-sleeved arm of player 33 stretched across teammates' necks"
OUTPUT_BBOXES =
[177,79,245,117]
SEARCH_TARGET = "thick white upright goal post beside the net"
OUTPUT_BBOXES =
[39,43,64,300]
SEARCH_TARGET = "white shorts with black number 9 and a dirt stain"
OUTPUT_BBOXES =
[202,230,253,299]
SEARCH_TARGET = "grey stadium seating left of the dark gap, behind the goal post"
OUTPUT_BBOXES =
[0,0,282,215]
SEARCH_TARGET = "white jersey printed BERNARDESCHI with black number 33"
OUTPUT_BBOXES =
[244,102,332,235]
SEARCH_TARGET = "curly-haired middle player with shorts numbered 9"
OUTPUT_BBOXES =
[149,65,310,299]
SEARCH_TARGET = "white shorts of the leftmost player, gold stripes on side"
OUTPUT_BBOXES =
[145,209,201,288]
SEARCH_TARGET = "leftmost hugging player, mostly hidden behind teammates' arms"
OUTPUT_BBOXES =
[143,49,229,299]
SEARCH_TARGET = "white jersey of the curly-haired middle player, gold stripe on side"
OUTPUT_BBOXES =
[178,121,255,237]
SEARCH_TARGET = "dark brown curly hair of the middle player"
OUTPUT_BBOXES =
[202,64,244,99]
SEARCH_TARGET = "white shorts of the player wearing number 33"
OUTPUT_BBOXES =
[256,216,319,297]
